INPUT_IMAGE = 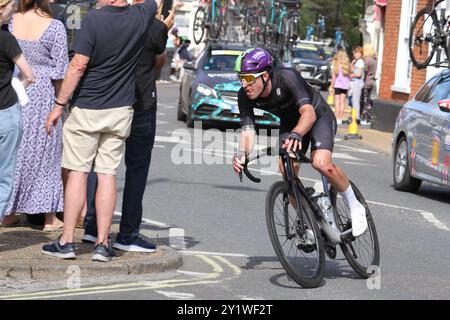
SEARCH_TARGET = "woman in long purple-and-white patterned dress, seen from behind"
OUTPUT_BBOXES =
[2,0,68,231]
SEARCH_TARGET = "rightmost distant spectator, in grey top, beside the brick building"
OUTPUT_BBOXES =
[361,44,377,125]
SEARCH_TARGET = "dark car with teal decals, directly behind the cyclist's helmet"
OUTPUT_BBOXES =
[177,44,281,128]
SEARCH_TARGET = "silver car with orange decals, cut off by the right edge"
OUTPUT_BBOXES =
[392,70,450,192]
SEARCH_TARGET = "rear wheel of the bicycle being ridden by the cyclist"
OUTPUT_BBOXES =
[330,181,380,279]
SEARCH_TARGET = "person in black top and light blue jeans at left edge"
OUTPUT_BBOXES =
[0,0,34,219]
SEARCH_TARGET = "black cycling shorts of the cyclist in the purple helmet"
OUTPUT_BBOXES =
[278,110,337,153]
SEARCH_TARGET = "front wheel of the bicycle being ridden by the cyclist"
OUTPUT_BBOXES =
[266,181,325,288]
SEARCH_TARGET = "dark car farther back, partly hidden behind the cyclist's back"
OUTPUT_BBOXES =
[293,44,330,90]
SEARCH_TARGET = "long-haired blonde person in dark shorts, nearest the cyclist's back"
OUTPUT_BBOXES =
[331,49,351,125]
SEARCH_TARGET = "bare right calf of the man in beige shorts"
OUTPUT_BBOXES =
[95,173,117,246]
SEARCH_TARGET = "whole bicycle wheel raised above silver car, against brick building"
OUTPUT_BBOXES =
[408,8,440,69]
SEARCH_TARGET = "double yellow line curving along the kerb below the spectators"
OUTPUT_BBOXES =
[0,255,241,300]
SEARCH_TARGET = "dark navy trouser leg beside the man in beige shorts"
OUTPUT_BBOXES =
[120,111,156,241]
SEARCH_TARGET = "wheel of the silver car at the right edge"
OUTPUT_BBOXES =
[394,137,422,192]
